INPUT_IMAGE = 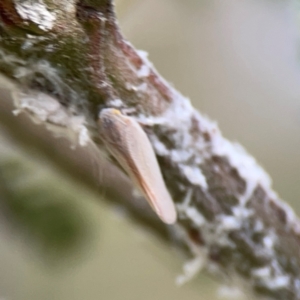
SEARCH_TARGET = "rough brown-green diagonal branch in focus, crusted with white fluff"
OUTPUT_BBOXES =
[0,0,300,300]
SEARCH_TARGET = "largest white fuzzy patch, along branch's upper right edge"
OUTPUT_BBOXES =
[157,92,271,205]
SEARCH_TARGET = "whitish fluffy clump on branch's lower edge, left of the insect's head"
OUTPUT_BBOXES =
[13,92,90,146]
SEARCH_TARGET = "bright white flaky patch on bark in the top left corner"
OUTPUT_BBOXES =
[16,0,56,31]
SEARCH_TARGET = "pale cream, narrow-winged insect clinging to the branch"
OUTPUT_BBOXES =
[99,108,176,224]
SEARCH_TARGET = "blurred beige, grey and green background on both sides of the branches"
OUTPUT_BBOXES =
[0,0,300,300]
